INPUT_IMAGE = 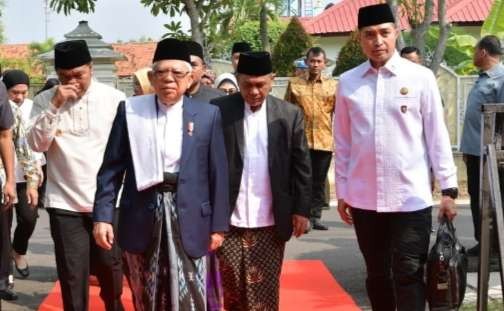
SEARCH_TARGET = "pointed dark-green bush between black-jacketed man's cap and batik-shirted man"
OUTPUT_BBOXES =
[272,17,313,76]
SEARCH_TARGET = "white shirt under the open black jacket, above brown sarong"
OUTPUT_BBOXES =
[231,101,275,228]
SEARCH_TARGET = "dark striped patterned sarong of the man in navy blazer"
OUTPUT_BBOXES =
[123,192,206,311]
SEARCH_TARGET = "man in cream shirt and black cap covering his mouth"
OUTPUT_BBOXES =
[28,40,125,310]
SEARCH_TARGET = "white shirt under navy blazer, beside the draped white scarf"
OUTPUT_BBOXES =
[157,97,184,173]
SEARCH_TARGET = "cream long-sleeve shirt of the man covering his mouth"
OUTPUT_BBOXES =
[28,80,125,213]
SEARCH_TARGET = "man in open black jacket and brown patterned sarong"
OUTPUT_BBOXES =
[212,52,311,310]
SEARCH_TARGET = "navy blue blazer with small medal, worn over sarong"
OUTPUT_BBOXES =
[93,97,229,258]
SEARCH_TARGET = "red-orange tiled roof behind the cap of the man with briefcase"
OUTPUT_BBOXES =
[302,0,493,35]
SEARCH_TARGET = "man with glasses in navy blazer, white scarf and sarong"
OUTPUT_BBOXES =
[94,39,229,310]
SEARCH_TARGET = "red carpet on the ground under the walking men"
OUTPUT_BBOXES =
[39,260,360,311]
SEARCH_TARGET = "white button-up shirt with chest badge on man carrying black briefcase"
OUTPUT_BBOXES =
[333,53,457,212]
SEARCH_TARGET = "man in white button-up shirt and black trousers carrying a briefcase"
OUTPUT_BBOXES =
[333,4,458,311]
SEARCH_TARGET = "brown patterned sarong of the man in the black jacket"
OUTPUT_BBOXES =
[218,226,285,311]
